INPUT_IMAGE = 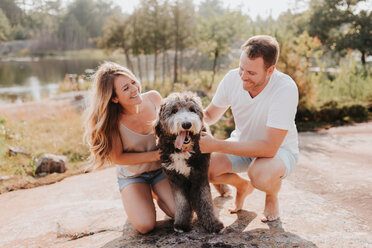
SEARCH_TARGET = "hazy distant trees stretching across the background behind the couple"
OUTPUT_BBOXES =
[0,0,372,87]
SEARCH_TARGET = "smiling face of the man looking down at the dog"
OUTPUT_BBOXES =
[239,51,275,97]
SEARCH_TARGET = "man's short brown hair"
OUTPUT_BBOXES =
[242,35,280,69]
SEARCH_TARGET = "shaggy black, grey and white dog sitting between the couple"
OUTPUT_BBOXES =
[155,92,223,233]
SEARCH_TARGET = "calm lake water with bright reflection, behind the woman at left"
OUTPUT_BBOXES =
[0,59,102,105]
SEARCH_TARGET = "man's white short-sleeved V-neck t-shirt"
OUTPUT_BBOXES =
[212,68,299,154]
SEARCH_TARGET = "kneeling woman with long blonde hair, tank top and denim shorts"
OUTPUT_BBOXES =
[85,62,175,234]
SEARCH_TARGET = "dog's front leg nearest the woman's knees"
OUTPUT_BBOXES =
[173,186,192,233]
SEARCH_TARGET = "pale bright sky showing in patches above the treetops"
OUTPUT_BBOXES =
[113,0,308,20]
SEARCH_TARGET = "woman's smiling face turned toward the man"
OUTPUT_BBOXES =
[112,75,142,108]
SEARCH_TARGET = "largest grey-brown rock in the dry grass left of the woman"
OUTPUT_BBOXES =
[35,154,67,175]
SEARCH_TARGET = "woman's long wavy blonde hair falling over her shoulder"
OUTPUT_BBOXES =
[84,62,139,168]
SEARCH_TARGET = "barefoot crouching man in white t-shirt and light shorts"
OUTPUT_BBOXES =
[199,35,299,221]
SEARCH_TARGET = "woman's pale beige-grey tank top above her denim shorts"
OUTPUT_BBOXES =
[116,114,160,178]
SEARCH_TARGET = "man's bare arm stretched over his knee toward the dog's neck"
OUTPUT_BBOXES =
[199,127,288,158]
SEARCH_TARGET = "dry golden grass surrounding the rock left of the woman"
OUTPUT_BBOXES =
[0,104,89,193]
